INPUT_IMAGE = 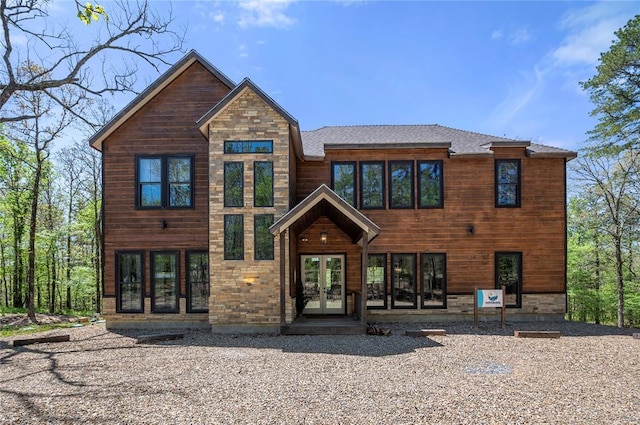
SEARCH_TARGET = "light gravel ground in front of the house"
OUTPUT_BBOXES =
[0,322,640,424]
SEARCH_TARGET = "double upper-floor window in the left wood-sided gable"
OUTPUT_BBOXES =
[136,155,193,208]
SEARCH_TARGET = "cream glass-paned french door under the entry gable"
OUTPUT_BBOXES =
[300,255,345,314]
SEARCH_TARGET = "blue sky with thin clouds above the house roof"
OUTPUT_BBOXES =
[69,0,640,149]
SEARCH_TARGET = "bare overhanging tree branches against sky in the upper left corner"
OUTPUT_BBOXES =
[0,0,183,124]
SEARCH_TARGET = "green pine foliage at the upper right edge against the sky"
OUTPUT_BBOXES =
[582,15,640,148]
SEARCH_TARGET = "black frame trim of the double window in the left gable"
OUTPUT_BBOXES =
[134,153,195,210]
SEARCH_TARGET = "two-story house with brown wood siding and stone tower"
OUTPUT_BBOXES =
[90,51,576,332]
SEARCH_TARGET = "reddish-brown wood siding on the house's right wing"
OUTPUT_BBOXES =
[297,148,565,294]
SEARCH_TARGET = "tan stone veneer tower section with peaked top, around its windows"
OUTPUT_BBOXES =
[209,88,292,333]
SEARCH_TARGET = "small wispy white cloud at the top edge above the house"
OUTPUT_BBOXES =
[238,0,295,28]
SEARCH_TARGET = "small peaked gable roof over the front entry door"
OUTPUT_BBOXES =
[269,184,380,245]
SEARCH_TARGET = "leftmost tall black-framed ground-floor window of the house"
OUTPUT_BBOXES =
[116,252,144,313]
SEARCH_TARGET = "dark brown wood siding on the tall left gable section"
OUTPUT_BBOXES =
[103,63,230,297]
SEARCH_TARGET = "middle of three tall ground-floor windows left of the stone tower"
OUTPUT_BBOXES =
[151,252,179,313]
